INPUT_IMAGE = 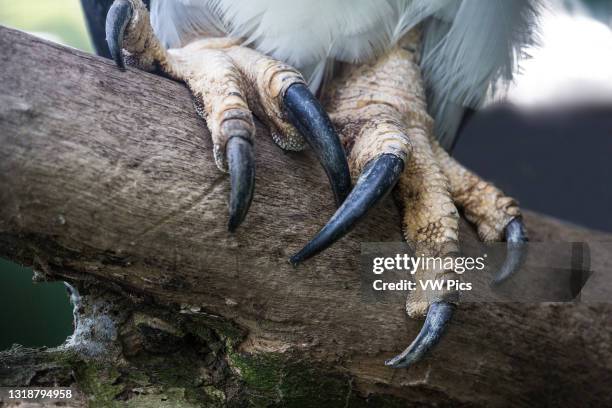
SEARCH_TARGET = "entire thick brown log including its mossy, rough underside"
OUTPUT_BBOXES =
[0,28,612,406]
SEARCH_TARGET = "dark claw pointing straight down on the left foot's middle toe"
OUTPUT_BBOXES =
[225,136,255,232]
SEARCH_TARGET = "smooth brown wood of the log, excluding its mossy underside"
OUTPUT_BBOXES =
[0,28,612,406]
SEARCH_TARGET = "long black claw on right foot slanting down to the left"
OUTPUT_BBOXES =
[290,154,404,265]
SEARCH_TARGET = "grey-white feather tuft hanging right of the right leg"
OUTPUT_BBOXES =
[421,0,537,148]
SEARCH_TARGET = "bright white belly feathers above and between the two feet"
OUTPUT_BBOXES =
[212,0,406,67]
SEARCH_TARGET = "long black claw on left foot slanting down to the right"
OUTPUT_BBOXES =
[283,83,351,206]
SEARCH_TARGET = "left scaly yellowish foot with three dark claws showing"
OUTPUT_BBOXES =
[106,0,350,231]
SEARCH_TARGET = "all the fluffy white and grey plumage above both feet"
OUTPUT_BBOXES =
[151,0,536,147]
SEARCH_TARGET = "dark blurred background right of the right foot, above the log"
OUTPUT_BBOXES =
[454,103,612,231]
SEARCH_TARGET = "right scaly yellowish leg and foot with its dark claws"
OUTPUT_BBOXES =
[291,33,525,367]
